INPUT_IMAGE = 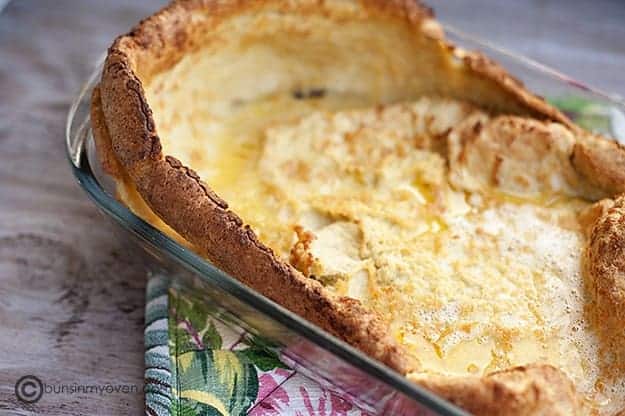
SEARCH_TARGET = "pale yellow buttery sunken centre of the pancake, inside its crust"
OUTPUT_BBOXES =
[144,92,625,413]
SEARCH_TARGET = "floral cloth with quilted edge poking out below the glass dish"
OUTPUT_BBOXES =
[145,275,366,416]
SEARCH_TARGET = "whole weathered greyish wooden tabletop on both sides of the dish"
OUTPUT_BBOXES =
[0,0,625,415]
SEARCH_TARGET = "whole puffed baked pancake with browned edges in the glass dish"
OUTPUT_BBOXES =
[92,0,625,415]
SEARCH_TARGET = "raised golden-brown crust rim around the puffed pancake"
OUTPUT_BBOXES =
[92,0,625,415]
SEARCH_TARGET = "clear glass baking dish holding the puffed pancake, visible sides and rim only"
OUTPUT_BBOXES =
[66,27,625,415]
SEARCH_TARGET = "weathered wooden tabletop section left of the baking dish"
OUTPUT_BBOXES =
[0,1,166,415]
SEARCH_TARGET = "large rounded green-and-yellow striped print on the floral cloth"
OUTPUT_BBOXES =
[172,350,258,416]
